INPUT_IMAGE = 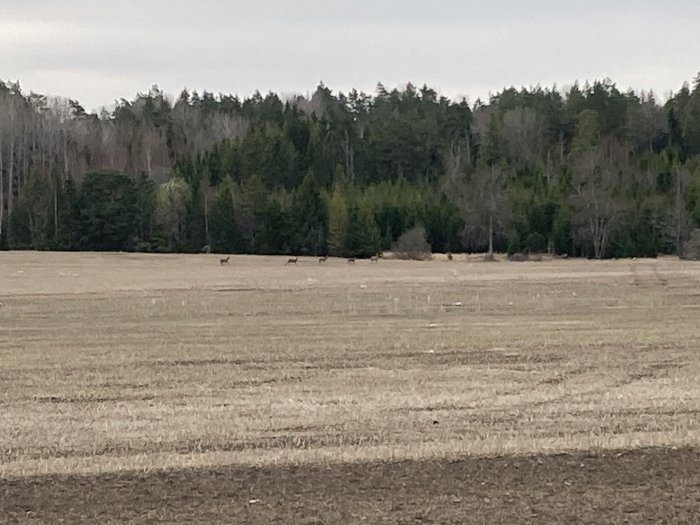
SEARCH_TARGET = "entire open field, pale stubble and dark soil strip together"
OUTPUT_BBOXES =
[0,252,700,523]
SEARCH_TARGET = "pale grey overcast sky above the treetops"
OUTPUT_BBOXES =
[0,0,700,110]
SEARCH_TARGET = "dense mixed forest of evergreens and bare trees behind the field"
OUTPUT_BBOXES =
[0,76,700,258]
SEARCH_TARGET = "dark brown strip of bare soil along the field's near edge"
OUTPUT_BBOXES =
[0,449,700,524]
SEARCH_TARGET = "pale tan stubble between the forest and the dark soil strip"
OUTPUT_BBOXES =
[0,252,700,477]
